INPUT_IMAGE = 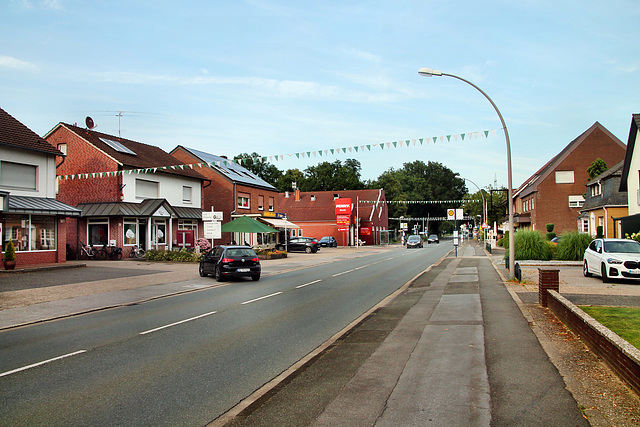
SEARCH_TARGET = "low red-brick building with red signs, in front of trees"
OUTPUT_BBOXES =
[279,189,389,246]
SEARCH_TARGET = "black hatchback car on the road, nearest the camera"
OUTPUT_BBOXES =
[198,246,262,282]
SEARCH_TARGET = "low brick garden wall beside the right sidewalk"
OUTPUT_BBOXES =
[547,290,640,394]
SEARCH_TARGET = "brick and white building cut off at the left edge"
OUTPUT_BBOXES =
[0,109,80,265]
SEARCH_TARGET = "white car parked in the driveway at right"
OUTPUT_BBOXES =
[582,239,640,283]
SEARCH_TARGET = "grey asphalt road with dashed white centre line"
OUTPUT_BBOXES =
[0,245,450,425]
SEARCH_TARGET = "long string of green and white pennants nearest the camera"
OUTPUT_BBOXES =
[57,129,497,180]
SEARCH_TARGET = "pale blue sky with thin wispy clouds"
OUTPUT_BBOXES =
[0,0,640,192]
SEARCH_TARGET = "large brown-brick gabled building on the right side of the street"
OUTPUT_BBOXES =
[513,122,626,234]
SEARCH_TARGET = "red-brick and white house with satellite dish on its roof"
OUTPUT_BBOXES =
[45,123,207,256]
